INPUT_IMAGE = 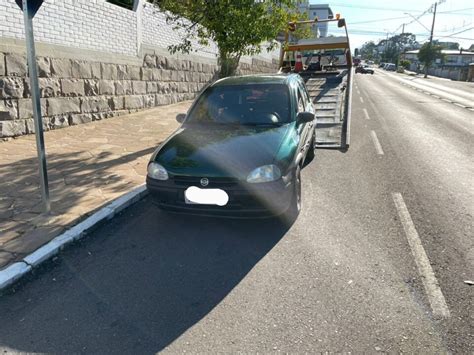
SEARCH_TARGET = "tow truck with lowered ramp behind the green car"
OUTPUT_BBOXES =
[279,14,353,151]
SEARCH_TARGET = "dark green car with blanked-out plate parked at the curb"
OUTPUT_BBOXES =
[146,74,316,219]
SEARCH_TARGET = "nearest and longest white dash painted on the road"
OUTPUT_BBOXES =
[392,192,450,318]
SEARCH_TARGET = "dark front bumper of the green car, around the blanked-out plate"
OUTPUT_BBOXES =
[146,177,293,218]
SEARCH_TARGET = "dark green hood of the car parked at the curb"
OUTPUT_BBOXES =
[152,124,292,179]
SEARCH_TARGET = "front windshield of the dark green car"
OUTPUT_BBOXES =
[186,84,291,125]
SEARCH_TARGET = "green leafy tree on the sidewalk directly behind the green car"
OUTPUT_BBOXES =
[154,0,296,77]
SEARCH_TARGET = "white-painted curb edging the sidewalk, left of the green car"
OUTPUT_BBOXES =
[0,185,148,291]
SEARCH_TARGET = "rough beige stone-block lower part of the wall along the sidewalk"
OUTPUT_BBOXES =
[0,53,277,138]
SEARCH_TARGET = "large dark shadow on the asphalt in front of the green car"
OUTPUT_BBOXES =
[0,199,288,353]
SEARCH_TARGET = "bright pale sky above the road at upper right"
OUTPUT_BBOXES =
[310,0,474,48]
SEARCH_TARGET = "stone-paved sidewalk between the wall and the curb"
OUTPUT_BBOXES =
[0,101,191,270]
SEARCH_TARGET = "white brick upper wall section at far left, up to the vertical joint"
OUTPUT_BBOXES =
[0,0,138,55]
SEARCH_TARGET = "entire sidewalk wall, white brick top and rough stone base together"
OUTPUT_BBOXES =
[0,0,277,138]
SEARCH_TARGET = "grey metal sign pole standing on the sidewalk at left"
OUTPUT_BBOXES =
[23,0,51,213]
